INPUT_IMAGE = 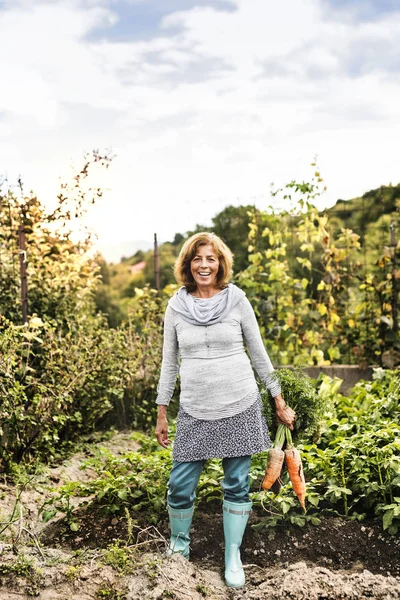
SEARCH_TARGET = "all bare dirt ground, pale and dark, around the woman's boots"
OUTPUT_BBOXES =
[0,433,400,600]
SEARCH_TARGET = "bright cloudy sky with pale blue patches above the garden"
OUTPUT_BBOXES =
[0,0,400,258]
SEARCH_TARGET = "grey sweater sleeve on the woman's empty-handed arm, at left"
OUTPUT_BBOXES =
[156,306,179,406]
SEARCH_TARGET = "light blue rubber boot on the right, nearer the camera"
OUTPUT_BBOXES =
[223,500,252,588]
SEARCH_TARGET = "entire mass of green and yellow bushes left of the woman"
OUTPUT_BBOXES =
[0,153,173,472]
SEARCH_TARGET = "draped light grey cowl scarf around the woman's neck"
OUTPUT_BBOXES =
[168,283,245,325]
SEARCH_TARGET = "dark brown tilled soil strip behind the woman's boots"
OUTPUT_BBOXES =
[192,510,400,576]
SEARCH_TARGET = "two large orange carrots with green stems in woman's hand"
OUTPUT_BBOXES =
[262,423,306,511]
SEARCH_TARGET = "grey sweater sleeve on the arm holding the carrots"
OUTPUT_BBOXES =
[241,298,282,398]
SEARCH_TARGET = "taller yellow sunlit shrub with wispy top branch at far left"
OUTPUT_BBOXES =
[0,152,111,331]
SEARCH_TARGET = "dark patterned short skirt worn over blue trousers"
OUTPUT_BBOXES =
[172,393,271,462]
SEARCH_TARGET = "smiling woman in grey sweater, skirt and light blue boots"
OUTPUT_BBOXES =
[156,233,295,588]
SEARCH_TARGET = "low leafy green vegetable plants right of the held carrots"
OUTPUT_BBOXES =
[252,369,400,534]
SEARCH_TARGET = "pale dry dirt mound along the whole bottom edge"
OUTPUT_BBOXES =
[0,551,400,600]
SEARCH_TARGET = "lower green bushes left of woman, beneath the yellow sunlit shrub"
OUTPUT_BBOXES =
[0,289,164,470]
